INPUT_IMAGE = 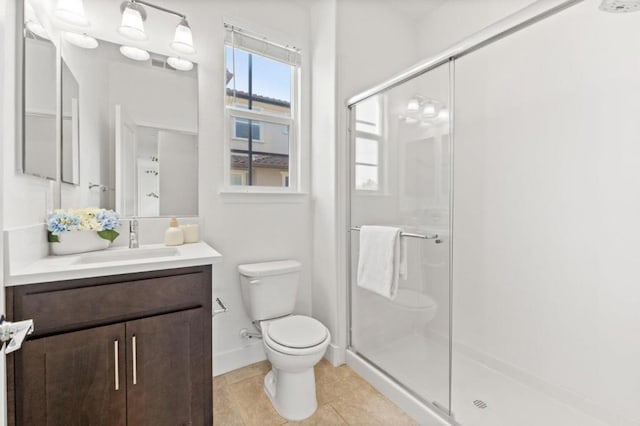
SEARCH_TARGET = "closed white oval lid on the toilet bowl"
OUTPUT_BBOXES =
[268,315,327,348]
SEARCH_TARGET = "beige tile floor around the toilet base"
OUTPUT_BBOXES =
[213,360,416,426]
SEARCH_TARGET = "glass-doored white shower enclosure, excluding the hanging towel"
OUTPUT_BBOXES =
[348,0,640,426]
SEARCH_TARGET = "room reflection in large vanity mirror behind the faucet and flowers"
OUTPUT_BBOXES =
[61,39,198,217]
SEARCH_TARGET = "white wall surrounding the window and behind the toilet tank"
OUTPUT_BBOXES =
[180,0,311,373]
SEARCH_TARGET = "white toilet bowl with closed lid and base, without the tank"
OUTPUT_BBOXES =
[260,315,331,420]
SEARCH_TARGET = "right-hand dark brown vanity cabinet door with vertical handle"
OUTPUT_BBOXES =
[126,308,205,426]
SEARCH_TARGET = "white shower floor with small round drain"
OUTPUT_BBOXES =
[360,335,606,426]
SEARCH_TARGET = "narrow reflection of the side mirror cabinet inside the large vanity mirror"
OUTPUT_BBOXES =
[62,59,80,185]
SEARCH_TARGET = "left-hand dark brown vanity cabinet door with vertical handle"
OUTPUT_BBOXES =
[16,324,127,426]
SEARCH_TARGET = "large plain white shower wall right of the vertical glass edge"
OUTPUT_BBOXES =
[453,1,640,425]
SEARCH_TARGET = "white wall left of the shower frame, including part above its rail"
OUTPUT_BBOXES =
[311,0,424,364]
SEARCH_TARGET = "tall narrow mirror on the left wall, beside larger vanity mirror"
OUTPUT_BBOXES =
[22,15,57,180]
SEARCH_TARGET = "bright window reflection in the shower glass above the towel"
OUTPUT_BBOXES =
[354,96,382,191]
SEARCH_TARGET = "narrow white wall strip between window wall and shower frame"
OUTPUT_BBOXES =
[311,0,345,364]
